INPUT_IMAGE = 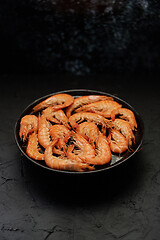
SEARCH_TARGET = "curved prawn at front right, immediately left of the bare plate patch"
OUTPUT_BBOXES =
[85,133,112,165]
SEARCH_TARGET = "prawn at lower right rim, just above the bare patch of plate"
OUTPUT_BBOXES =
[108,129,128,154]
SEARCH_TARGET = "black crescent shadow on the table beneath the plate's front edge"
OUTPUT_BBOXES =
[20,152,143,205]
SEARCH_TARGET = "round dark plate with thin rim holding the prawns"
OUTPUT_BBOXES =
[15,89,144,174]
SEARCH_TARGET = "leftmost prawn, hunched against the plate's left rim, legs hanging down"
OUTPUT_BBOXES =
[19,115,38,142]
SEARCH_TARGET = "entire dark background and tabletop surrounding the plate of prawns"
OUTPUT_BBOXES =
[0,0,160,240]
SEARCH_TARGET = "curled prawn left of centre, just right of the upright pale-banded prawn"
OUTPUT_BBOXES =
[49,125,71,154]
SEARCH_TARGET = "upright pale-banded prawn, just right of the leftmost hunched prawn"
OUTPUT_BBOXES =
[38,115,51,148]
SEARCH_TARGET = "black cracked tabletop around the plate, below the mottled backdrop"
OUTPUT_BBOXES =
[0,74,160,240]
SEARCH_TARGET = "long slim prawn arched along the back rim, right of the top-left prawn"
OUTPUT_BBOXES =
[66,95,113,118]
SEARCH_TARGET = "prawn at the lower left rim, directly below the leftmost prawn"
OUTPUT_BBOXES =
[26,132,44,160]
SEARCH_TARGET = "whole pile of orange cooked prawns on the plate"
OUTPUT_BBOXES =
[19,94,137,171]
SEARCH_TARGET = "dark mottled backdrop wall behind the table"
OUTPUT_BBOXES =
[0,0,160,75]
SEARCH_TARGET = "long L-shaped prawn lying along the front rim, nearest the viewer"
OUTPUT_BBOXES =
[44,139,94,172]
